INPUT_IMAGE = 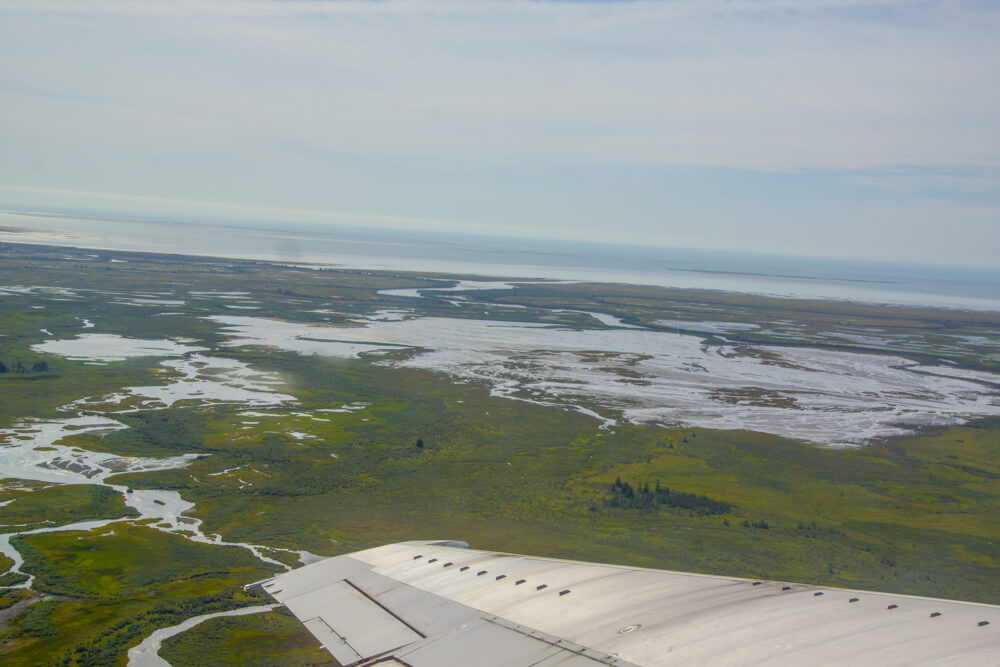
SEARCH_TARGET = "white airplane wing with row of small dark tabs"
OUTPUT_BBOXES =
[259,541,1000,667]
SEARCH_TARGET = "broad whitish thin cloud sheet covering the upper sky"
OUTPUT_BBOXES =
[3,2,1000,168]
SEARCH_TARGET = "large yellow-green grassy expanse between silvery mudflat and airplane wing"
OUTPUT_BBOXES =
[95,352,1000,601]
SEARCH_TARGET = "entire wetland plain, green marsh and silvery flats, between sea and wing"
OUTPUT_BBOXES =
[0,245,1000,665]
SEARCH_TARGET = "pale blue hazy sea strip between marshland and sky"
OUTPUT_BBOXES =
[0,211,1000,312]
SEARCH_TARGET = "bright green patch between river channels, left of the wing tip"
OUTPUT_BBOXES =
[0,522,274,666]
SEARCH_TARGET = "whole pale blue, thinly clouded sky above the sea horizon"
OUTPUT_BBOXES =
[0,0,1000,268]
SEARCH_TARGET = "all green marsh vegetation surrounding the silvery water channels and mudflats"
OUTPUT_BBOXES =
[0,245,1000,665]
